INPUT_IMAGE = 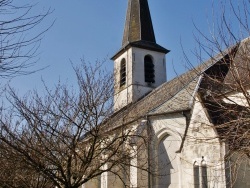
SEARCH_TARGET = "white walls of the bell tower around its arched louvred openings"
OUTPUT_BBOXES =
[114,47,166,111]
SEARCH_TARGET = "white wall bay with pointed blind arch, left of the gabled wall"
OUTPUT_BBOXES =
[150,113,186,188]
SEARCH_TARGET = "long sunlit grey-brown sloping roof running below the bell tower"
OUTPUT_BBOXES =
[108,47,231,129]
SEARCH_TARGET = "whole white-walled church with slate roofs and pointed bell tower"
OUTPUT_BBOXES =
[84,0,250,188]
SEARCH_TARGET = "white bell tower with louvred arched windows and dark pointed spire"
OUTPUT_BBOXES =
[111,0,169,111]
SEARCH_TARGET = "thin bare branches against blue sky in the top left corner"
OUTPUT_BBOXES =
[0,0,51,78]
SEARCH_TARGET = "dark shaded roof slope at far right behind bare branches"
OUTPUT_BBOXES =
[195,38,250,156]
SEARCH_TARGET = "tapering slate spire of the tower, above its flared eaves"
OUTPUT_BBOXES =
[122,0,156,46]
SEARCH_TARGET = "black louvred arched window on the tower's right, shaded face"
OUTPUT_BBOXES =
[144,55,155,83]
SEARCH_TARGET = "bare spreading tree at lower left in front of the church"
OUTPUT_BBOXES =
[0,63,146,188]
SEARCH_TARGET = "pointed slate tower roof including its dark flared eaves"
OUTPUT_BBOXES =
[111,0,169,59]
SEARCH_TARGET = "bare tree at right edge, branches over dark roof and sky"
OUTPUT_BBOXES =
[185,0,250,186]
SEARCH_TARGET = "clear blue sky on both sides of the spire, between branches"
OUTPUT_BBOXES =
[8,0,246,93]
